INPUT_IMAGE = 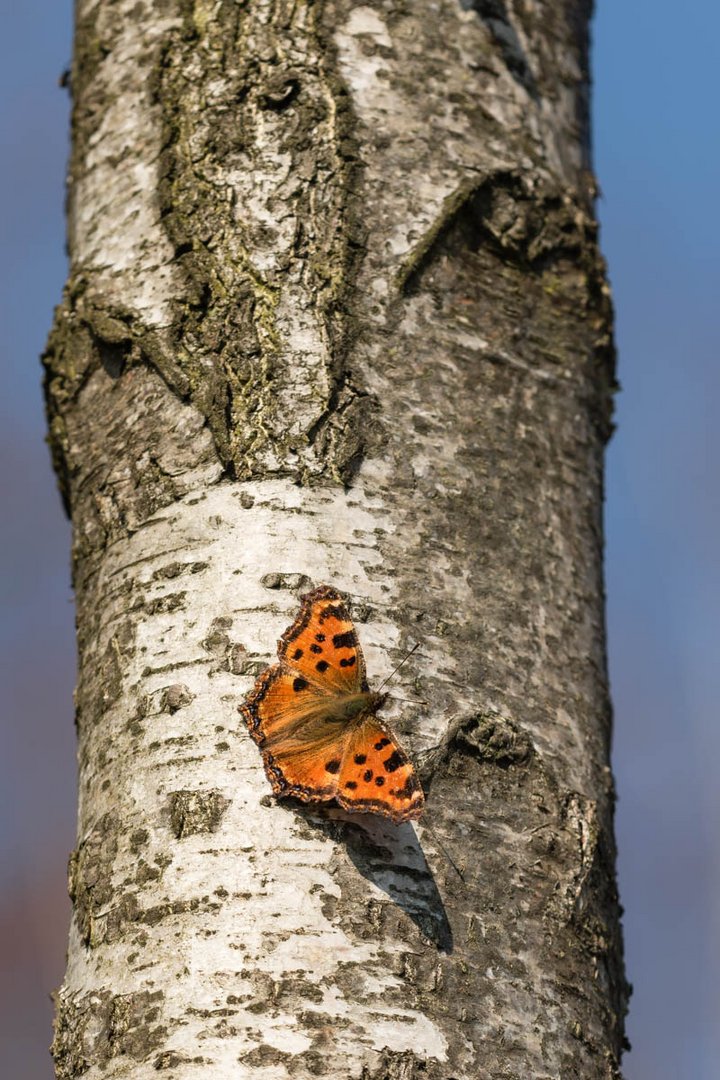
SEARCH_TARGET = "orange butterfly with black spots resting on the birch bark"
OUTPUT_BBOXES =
[240,585,424,823]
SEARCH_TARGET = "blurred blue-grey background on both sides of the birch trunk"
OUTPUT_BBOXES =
[0,0,720,1080]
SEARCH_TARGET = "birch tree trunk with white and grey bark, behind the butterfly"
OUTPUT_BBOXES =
[44,0,626,1080]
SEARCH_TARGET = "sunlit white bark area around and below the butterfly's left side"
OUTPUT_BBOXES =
[62,481,455,1080]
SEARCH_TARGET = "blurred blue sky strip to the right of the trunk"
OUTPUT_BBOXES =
[594,0,720,1080]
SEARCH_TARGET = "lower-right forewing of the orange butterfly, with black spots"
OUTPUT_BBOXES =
[336,715,425,823]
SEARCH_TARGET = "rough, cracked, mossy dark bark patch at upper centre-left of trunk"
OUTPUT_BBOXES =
[144,4,375,488]
